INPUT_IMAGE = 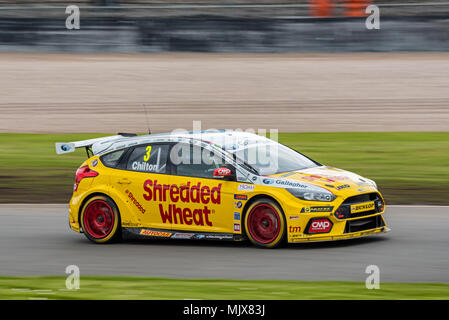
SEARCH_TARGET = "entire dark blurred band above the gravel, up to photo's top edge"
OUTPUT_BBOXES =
[0,0,449,52]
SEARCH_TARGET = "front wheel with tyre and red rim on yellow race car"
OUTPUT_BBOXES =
[245,198,287,248]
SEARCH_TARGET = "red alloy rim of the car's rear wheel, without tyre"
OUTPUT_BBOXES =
[83,200,114,239]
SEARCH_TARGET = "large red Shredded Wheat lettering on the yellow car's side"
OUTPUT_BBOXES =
[143,179,221,226]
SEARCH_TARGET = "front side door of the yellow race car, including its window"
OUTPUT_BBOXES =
[166,143,240,233]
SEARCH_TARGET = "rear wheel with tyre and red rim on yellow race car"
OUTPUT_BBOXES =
[80,195,121,243]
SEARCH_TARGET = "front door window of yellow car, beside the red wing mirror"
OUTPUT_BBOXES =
[172,144,227,179]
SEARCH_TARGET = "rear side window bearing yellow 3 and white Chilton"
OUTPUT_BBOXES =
[126,144,168,173]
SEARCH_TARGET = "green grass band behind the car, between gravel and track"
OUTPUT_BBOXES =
[0,132,449,204]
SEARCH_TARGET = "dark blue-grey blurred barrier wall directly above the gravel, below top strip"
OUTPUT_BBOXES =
[0,16,449,53]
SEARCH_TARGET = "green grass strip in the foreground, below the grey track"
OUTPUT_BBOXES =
[0,276,449,300]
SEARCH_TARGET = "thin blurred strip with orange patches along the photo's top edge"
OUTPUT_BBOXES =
[0,0,449,18]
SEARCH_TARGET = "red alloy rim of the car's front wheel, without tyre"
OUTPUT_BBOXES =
[248,203,281,244]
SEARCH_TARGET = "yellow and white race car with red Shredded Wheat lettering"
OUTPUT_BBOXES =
[56,130,389,248]
